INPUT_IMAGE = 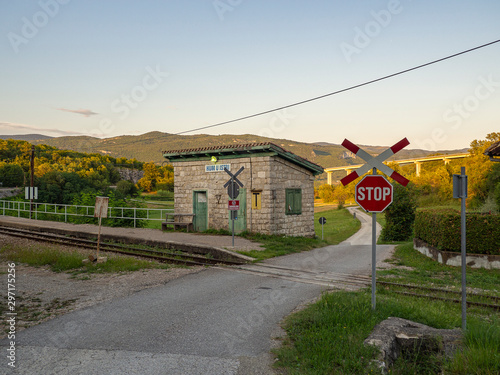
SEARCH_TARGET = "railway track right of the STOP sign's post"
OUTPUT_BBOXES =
[377,281,500,310]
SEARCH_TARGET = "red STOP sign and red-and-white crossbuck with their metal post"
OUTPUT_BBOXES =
[340,138,410,310]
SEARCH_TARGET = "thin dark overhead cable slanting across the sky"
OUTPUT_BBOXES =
[175,39,500,135]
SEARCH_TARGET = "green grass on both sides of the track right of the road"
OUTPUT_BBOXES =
[274,244,500,374]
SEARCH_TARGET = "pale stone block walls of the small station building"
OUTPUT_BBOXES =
[173,156,314,236]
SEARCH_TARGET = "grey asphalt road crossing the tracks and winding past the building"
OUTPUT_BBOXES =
[0,207,393,375]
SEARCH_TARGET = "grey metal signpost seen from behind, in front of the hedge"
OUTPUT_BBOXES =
[453,167,468,331]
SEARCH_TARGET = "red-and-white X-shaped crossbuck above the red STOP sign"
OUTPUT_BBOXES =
[340,138,410,186]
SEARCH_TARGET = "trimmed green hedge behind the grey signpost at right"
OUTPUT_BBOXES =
[415,209,500,255]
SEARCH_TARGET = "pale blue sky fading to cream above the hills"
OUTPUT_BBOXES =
[0,0,500,150]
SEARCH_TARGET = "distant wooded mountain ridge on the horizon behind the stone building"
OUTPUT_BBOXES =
[33,132,466,183]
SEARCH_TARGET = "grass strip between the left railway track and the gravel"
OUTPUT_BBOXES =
[0,245,171,275]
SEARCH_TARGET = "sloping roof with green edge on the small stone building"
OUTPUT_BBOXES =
[162,142,323,175]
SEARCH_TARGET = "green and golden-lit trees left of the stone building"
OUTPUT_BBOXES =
[0,139,173,205]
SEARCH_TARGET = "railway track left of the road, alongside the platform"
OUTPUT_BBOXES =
[0,226,241,266]
